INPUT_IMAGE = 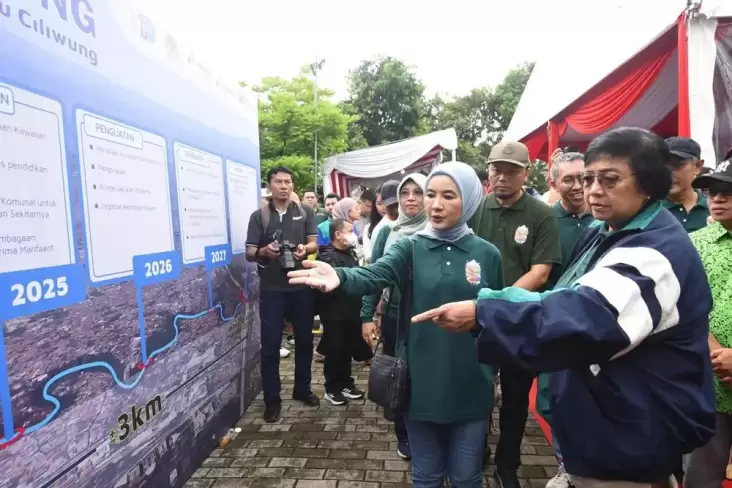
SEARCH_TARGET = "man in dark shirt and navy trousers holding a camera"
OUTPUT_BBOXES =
[246,166,319,423]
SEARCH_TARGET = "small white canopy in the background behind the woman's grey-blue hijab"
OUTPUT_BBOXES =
[323,128,457,197]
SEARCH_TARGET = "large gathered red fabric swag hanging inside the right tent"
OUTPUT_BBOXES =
[565,40,673,134]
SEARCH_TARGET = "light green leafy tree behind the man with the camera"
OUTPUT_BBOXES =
[254,68,355,191]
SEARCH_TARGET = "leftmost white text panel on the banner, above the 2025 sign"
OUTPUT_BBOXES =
[0,84,76,273]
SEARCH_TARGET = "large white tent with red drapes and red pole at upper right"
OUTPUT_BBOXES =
[505,0,732,165]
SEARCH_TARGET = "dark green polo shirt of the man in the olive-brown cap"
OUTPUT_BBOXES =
[468,192,562,286]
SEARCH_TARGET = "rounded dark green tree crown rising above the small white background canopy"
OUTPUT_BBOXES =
[347,56,424,146]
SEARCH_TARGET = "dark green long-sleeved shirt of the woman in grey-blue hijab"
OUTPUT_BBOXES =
[336,234,504,423]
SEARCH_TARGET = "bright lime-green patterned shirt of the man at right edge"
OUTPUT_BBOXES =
[690,222,732,414]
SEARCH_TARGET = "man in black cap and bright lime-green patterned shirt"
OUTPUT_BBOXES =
[684,158,732,488]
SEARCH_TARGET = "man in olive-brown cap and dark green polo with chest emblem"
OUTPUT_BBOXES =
[469,141,562,488]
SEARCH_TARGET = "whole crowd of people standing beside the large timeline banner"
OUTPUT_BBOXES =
[247,128,732,488]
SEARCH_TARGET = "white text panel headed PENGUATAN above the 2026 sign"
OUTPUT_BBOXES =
[76,110,175,285]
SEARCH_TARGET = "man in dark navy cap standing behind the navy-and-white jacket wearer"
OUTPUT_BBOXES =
[663,137,709,232]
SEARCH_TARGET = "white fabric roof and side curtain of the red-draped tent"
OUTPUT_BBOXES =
[505,0,732,164]
